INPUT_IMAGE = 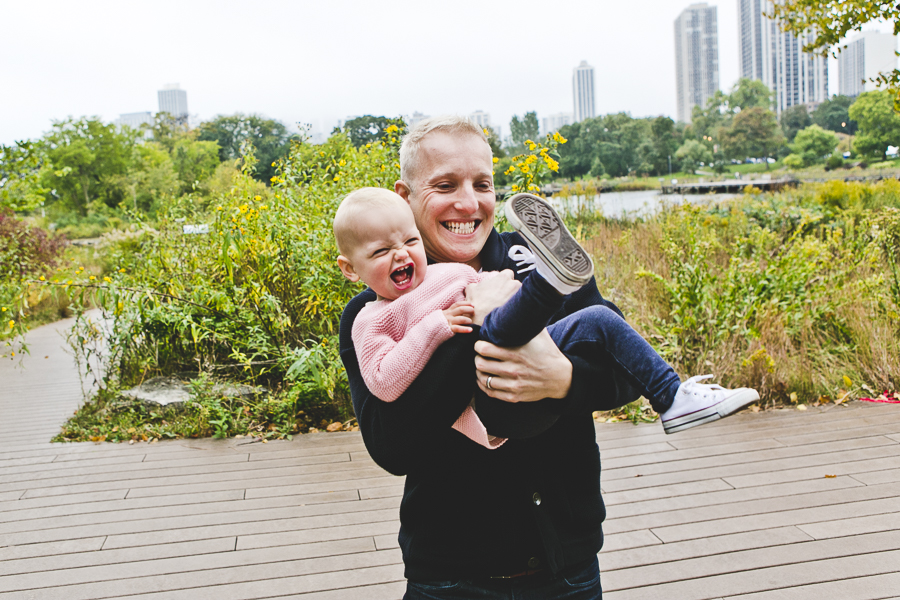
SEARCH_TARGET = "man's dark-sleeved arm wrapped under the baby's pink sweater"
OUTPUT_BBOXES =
[340,290,477,475]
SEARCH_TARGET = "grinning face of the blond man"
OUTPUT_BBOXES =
[397,131,496,269]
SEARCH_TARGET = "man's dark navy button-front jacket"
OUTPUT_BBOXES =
[340,230,637,581]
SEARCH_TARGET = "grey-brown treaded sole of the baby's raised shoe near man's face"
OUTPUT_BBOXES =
[504,194,594,286]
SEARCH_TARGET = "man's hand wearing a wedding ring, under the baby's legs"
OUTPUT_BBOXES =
[475,328,572,402]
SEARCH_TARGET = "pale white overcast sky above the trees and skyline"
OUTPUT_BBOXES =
[0,0,856,144]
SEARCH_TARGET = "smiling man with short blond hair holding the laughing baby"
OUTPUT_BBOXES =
[341,117,637,600]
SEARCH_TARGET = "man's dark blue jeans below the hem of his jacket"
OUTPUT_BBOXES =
[403,558,603,600]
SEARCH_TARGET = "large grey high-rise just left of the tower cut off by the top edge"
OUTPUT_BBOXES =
[675,2,719,123]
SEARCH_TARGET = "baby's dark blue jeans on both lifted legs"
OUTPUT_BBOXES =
[481,272,681,413]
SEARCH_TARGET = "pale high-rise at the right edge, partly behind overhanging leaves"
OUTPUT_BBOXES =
[838,31,897,96]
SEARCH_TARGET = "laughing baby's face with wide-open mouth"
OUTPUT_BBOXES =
[342,206,428,300]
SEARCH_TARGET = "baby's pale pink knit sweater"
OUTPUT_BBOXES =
[352,263,506,449]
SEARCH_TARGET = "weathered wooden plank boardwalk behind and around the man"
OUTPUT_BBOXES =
[0,327,900,600]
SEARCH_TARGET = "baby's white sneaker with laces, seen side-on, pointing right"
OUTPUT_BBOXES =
[661,375,759,433]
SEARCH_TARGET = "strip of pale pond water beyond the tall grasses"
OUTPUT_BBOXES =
[551,190,737,219]
